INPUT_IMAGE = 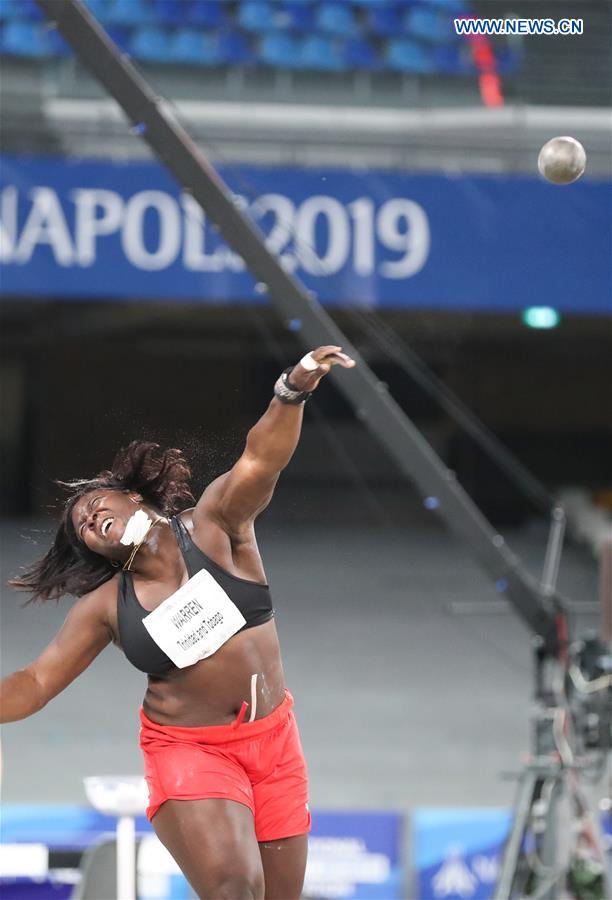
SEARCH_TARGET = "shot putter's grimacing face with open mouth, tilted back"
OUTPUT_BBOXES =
[72,488,141,560]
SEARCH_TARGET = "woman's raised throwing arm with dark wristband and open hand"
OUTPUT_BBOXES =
[193,346,355,539]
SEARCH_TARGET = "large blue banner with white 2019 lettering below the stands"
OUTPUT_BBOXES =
[0,156,612,314]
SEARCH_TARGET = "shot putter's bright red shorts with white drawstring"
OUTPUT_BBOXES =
[140,691,310,841]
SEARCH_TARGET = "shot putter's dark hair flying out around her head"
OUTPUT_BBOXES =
[9,441,194,603]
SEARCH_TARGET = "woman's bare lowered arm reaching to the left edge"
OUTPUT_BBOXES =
[0,582,116,723]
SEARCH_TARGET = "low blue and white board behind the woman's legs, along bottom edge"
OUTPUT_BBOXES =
[0,804,405,900]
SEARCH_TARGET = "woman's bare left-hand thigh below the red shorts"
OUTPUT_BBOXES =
[152,798,263,900]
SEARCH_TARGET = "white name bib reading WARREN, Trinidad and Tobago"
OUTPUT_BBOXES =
[142,569,246,669]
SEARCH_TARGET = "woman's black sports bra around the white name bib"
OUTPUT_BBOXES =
[117,516,274,675]
